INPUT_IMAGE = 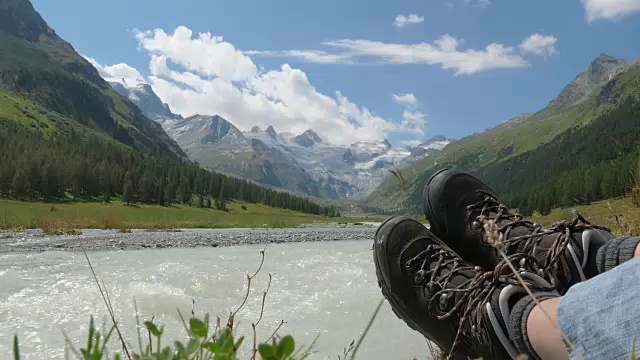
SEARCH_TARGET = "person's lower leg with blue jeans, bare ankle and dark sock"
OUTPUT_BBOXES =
[496,255,640,360]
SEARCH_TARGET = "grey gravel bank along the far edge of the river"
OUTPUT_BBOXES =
[0,223,377,252]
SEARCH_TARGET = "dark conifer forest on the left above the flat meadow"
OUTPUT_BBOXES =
[0,121,338,216]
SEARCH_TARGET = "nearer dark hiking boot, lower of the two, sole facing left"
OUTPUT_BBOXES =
[373,217,558,360]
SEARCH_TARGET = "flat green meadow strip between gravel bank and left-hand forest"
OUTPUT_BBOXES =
[0,200,380,232]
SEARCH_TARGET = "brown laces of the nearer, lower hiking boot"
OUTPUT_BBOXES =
[405,245,551,356]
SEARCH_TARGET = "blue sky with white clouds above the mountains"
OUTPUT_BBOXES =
[32,0,640,146]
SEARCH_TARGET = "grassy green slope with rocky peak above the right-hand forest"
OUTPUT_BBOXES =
[365,54,640,211]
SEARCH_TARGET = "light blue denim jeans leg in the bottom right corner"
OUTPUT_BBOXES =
[557,258,640,360]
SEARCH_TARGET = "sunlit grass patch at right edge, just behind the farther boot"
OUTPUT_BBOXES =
[529,197,640,235]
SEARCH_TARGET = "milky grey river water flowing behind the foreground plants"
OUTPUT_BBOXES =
[0,239,436,360]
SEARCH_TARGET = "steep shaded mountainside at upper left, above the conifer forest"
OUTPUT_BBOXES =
[0,0,185,158]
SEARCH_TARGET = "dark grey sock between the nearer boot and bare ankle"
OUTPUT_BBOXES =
[508,292,558,360]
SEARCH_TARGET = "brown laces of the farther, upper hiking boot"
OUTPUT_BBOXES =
[467,197,609,285]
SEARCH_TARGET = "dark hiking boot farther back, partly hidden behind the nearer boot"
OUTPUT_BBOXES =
[424,169,613,294]
